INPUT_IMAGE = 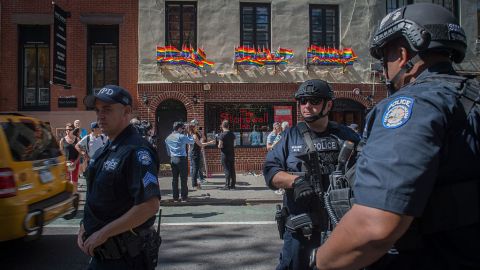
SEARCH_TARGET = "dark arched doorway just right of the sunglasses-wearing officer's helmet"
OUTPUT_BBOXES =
[329,98,366,130]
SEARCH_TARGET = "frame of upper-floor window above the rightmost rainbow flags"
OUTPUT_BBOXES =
[308,4,340,48]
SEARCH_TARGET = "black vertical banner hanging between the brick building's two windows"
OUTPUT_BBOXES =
[52,5,67,85]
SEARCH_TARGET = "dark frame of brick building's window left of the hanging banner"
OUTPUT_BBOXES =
[17,25,52,111]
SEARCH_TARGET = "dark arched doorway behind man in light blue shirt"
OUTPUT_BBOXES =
[156,99,187,164]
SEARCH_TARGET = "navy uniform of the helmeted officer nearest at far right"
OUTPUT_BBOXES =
[354,63,480,269]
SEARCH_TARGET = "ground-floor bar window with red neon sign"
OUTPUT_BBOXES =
[205,102,296,147]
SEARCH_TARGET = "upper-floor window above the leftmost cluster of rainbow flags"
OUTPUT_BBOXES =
[165,2,197,50]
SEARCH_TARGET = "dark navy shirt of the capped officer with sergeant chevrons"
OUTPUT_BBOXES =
[84,125,160,235]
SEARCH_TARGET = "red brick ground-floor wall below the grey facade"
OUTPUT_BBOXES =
[138,83,386,173]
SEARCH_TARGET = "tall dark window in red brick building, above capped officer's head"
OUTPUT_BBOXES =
[87,25,118,94]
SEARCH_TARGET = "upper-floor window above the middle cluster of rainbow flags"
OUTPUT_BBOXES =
[240,3,270,49]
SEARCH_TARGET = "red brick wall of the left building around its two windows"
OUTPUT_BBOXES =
[0,0,138,111]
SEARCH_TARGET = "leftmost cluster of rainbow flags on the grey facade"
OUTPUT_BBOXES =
[157,45,215,69]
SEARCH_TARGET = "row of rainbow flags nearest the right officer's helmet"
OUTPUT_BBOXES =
[307,45,357,67]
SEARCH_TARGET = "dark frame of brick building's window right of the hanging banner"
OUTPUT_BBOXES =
[86,24,120,95]
